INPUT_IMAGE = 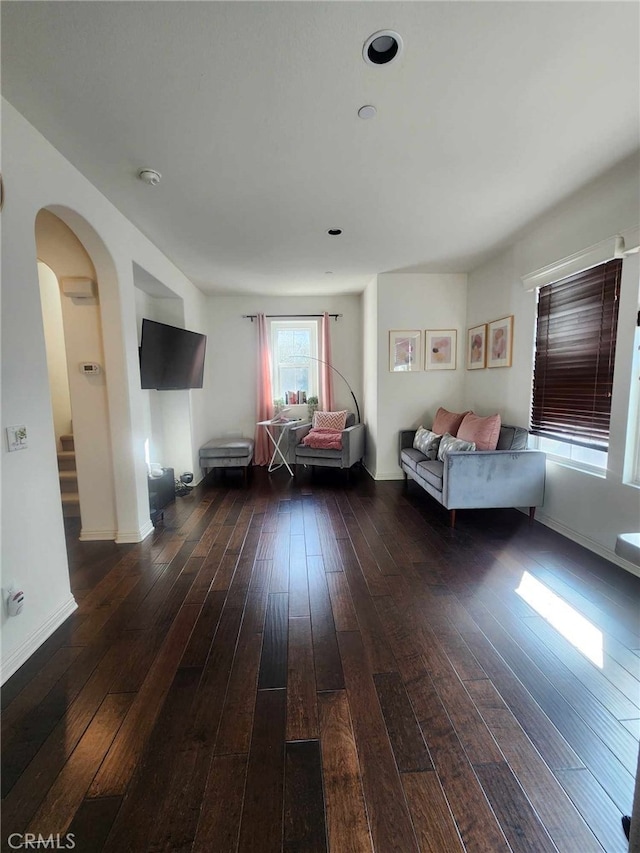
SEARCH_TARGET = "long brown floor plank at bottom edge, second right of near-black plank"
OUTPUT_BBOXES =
[338,632,418,853]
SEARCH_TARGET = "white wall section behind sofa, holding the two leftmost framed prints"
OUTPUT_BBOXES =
[368,273,467,480]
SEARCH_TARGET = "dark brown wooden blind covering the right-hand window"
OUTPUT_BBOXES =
[531,260,622,450]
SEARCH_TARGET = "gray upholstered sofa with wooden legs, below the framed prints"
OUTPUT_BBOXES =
[400,424,545,527]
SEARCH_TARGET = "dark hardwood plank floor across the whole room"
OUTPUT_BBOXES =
[2,470,640,853]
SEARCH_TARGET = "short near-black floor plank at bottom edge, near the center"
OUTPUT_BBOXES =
[282,740,327,853]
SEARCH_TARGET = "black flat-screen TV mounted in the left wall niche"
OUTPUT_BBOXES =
[140,318,207,391]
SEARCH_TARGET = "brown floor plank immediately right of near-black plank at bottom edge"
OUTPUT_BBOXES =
[318,690,373,853]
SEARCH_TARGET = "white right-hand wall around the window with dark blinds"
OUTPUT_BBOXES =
[465,157,640,572]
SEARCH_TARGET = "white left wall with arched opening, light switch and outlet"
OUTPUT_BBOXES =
[1,100,209,680]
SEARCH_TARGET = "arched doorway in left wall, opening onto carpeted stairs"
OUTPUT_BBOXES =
[35,210,117,540]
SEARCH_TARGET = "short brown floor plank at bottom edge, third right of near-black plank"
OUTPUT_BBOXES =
[402,771,464,853]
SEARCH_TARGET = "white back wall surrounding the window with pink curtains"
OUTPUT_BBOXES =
[208,295,363,443]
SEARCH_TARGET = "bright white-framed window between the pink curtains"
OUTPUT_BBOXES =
[270,319,318,406]
